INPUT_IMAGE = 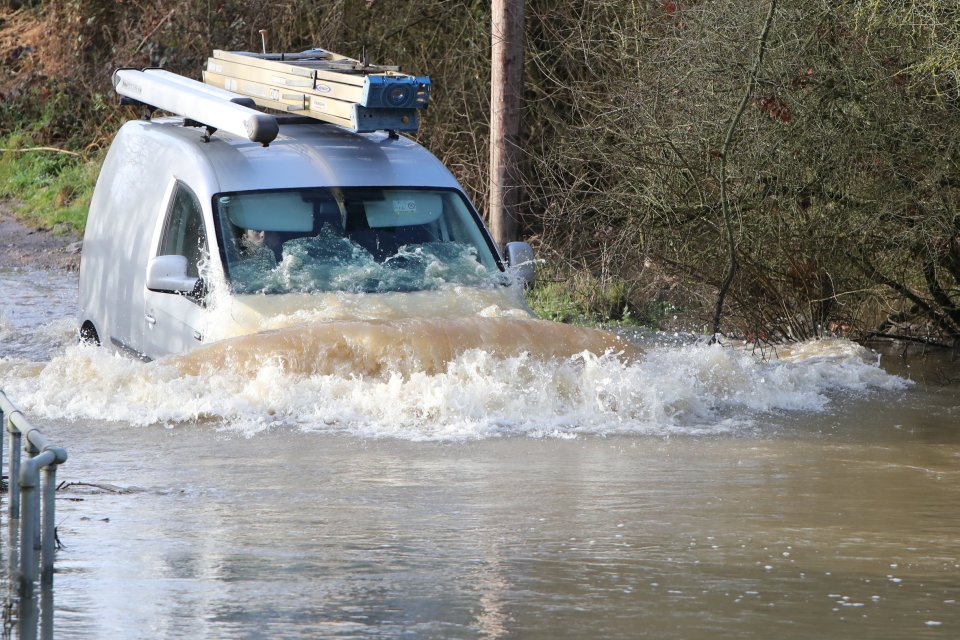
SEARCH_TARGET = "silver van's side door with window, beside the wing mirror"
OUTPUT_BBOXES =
[143,180,210,358]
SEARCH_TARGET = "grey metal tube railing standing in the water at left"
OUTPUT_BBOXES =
[0,391,67,602]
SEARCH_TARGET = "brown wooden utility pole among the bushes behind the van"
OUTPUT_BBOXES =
[490,0,524,248]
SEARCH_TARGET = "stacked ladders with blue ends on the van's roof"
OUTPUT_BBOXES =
[203,49,430,132]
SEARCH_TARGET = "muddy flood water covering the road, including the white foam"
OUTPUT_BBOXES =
[0,271,960,639]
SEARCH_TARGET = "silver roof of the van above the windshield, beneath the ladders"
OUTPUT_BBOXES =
[127,118,460,193]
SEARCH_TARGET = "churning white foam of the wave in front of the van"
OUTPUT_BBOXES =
[0,340,908,440]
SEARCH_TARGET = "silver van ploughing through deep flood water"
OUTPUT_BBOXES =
[80,109,532,360]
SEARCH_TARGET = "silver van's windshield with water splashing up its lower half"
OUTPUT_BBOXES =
[213,187,501,293]
